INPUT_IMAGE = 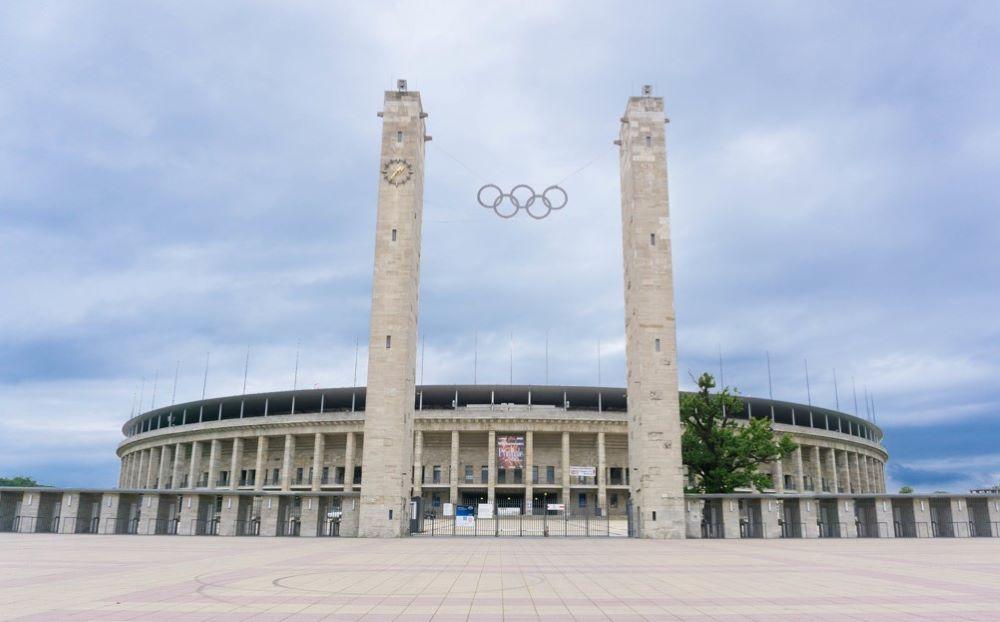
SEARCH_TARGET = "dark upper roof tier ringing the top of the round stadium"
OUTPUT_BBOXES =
[122,384,883,444]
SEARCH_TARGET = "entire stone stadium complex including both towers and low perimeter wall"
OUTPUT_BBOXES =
[0,81,1000,538]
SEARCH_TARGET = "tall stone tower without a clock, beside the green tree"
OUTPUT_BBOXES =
[617,86,685,538]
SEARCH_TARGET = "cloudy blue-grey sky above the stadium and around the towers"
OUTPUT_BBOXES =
[0,1,1000,490]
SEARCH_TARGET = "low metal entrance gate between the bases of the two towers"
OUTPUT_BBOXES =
[412,500,629,538]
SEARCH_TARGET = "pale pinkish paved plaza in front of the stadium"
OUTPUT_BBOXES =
[0,534,1000,622]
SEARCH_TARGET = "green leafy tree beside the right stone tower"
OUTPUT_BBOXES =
[681,374,797,493]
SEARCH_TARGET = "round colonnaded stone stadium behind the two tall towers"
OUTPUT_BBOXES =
[109,385,888,529]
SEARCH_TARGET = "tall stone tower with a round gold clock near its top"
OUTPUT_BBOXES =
[358,80,426,537]
